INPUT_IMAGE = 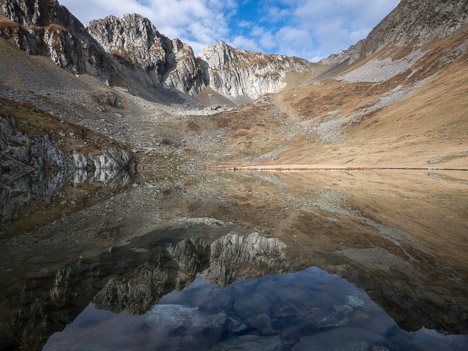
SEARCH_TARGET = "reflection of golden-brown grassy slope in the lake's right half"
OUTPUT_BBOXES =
[210,172,468,333]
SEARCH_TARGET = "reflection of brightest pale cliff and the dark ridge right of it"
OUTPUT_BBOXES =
[202,233,468,334]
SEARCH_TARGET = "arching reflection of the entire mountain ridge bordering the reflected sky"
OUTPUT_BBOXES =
[1,212,467,349]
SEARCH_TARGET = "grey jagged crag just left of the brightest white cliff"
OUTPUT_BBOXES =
[86,14,205,95]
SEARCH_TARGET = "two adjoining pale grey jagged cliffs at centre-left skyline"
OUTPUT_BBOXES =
[86,14,313,102]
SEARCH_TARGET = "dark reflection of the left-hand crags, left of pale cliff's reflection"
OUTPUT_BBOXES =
[2,232,210,349]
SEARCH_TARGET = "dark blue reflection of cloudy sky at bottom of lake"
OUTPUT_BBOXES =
[44,268,468,351]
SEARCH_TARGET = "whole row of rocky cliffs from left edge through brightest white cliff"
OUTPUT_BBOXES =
[0,0,313,103]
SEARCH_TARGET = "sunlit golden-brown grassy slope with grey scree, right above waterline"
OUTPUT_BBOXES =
[218,25,468,168]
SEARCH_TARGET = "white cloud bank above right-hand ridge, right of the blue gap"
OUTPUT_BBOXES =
[264,0,400,61]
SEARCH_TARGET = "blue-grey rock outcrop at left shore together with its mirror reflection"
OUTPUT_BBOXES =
[0,114,133,222]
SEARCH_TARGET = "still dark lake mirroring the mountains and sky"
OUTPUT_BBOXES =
[0,172,468,351]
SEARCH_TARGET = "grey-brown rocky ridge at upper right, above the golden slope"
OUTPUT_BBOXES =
[320,0,468,65]
